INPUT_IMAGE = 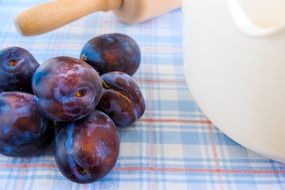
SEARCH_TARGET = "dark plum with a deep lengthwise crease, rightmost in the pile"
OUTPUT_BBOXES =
[98,72,145,127]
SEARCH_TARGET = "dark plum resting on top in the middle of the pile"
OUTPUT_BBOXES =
[32,57,102,121]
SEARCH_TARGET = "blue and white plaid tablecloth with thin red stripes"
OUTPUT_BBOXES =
[0,0,285,190]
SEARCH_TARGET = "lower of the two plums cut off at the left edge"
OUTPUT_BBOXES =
[0,92,54,157]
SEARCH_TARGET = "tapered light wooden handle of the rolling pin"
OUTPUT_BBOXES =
[15,0,122,36]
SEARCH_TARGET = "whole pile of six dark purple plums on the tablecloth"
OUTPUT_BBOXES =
[0,33,145,183]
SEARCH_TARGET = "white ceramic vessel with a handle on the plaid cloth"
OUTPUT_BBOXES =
[183,0,285,162]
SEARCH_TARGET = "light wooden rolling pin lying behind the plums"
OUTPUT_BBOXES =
[15,0,181,36]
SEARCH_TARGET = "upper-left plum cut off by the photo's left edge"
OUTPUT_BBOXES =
[0,47,39,93]
